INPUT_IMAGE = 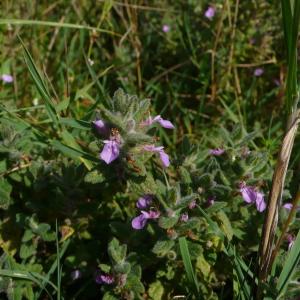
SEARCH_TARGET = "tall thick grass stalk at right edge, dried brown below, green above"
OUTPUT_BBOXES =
[257,0,300,299]
